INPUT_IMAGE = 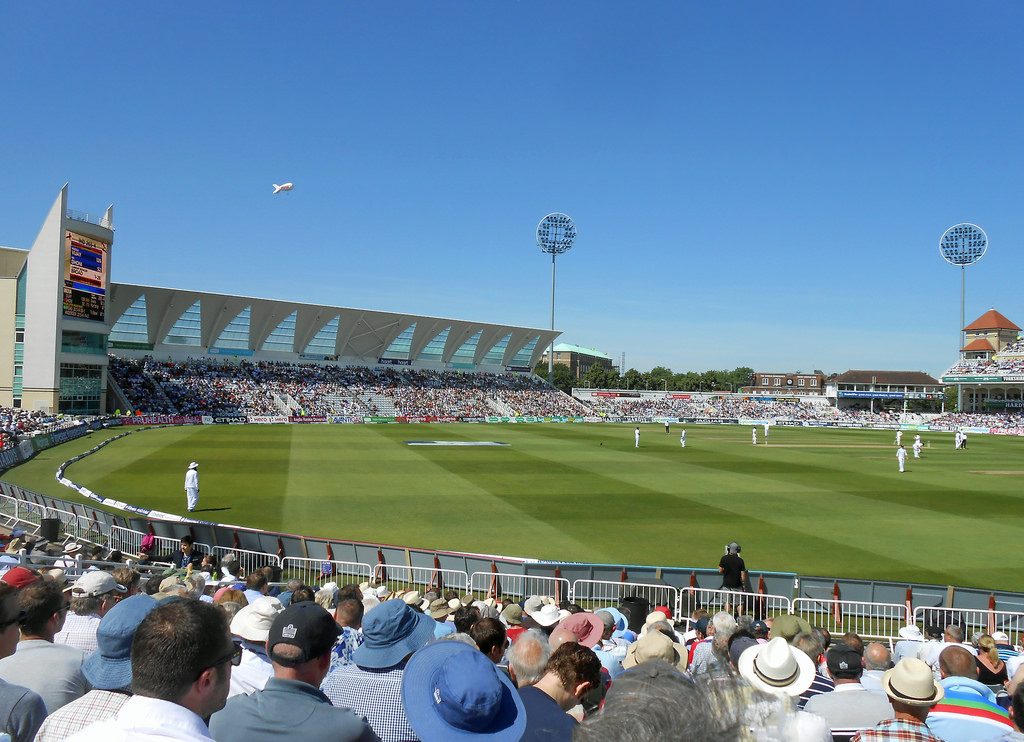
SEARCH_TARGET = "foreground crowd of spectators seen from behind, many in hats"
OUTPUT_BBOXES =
[0,537,1024,742]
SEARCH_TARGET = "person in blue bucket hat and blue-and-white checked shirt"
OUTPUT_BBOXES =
[323,600,434,742]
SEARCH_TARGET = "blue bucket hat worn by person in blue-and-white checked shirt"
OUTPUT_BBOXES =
[352,601,436,669]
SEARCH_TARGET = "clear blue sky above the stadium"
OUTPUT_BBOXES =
[0,0,1024,375]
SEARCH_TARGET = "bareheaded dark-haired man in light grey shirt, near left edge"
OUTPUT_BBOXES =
[0,580,89,713]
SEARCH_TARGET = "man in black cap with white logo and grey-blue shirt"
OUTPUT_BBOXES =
[210,601,379,742]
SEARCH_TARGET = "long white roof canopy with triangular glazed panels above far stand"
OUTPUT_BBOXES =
[106,283,561,368]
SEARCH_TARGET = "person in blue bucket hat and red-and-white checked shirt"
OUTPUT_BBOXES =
[36,595,157,742]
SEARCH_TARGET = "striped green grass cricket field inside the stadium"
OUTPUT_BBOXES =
[5,424,1024,591]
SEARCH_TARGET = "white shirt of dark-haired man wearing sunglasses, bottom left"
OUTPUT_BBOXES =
[66,696,213,742]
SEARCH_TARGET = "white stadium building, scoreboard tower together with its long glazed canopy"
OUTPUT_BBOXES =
[0,184,561,414]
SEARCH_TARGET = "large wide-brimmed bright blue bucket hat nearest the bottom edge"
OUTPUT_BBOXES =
[401,642,526,742]
